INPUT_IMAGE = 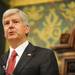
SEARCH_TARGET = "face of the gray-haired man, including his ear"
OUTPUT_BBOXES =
[3,14,29,40]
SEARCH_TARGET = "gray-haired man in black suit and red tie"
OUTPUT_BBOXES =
[0,8,59,75]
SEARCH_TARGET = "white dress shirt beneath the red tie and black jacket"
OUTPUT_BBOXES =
[6,41,29,68]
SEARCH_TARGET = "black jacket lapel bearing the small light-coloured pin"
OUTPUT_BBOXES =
[14,43,35,74]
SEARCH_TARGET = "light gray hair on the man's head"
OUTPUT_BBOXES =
[2,8,29,26]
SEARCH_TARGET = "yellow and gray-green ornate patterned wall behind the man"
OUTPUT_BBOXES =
[18,1,75,48]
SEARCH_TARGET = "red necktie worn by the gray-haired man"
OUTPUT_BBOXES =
[6,50,17,75]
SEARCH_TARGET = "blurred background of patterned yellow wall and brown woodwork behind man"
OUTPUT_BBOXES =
[0,0,75,75]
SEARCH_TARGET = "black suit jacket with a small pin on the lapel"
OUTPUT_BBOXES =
[0,43,59,75]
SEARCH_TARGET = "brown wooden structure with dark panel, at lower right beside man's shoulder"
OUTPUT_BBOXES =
[54,44,75,75]
